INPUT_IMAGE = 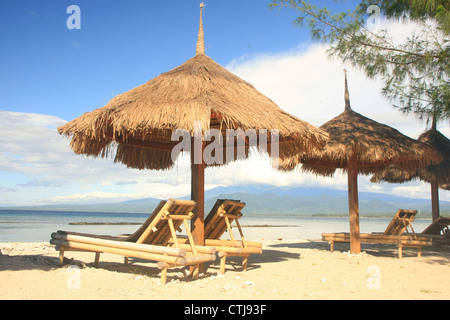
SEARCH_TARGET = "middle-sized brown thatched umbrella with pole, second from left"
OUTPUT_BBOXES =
[280,74,439,253]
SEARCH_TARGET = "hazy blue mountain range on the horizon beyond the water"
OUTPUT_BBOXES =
[4,185,450,216]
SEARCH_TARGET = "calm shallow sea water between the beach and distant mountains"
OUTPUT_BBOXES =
[0,210,431,242]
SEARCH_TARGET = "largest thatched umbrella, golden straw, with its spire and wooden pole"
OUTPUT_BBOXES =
[58,4,328,244]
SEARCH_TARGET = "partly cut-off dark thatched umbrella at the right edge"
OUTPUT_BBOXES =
[370,117,450,221]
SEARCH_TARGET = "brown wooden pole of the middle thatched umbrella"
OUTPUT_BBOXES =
[347,155,361,253]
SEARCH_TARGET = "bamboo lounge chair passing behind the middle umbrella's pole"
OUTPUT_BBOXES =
[322,209,432,258]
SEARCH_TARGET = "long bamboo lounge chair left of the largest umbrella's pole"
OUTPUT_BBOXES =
[50,199,216,284]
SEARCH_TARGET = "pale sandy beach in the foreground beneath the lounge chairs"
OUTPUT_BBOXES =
[0,240,450,300]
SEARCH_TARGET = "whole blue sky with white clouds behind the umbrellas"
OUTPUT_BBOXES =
[0,0,450,206]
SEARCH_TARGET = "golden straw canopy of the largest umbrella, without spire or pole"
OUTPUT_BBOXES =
[58,54,328,169]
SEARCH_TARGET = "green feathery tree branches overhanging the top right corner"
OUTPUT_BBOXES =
[272,0,450,125]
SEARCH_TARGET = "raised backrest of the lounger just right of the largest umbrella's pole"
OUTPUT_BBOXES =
[205,199,245,239]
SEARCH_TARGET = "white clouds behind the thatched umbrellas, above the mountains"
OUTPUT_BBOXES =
[0,21,450,205]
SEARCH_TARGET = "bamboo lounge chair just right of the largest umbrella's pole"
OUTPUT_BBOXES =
[205,199,262,274]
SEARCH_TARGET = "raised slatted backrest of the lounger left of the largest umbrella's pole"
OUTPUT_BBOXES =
[127,199,195,246]
